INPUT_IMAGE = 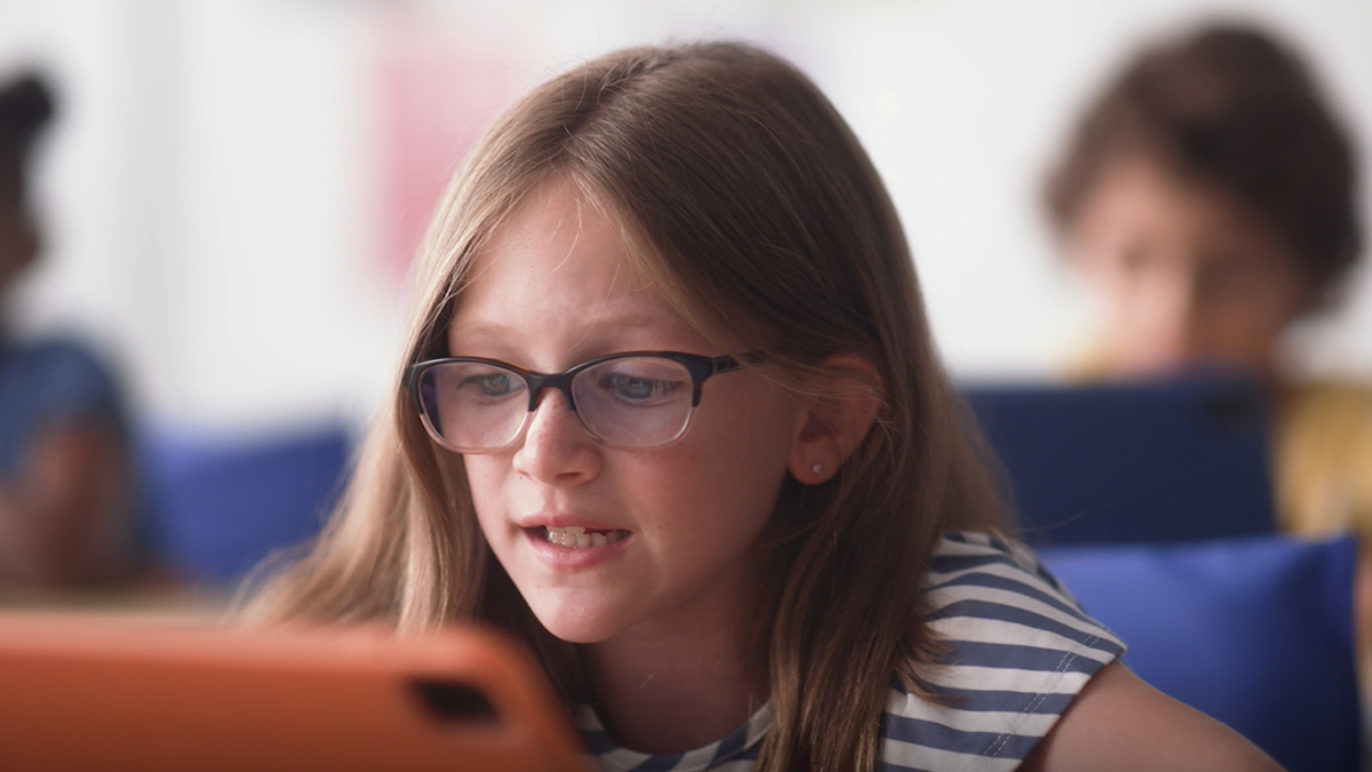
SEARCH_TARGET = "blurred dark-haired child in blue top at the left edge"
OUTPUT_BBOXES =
[0,74,139,591]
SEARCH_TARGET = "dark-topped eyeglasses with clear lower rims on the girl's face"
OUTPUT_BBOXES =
[405,351,757,453]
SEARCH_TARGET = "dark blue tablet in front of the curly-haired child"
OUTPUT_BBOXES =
[962,376,1275,544]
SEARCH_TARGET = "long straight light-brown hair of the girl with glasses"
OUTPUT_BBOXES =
[241,43,1000,769]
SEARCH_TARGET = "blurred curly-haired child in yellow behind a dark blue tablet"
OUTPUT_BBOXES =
[1044,23,1372,691]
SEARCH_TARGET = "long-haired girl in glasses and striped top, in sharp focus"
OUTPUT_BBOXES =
[252,44,1266,771]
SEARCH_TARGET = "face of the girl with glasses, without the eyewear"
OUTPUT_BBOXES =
[447,181,805,643]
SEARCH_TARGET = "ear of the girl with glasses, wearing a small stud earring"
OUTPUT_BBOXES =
[788,354,882,485]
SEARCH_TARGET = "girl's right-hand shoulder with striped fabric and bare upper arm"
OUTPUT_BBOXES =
[882,533,1276,771]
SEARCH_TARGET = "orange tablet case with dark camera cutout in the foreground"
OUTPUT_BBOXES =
[0,614,587,771]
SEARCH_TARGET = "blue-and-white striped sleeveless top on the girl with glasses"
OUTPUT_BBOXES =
[576,532,1124,772]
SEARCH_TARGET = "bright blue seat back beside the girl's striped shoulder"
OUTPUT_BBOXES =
[1040,536,1361,772]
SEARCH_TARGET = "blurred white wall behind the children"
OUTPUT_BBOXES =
[0,0,1372,428]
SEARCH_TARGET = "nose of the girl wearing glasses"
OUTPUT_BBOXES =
[512,388,601,485]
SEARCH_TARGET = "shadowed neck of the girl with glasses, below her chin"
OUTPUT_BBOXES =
[583,592,761,754]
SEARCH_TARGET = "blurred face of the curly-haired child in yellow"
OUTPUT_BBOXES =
[1066,159,1310,377]
